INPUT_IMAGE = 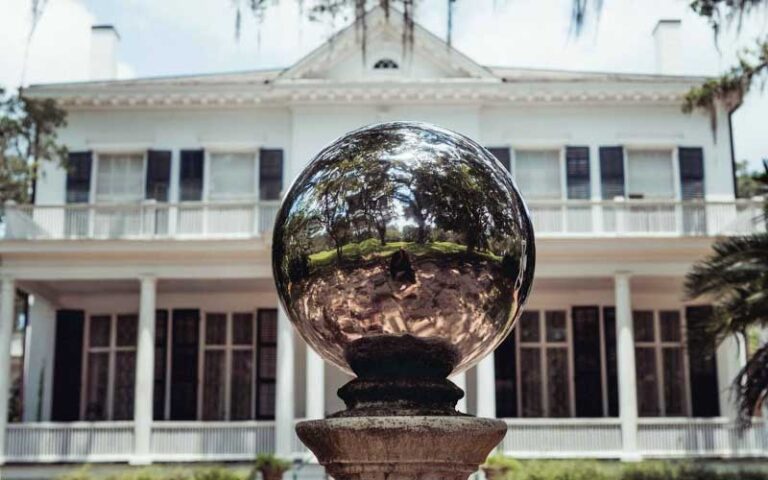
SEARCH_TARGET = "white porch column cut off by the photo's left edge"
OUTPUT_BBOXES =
[0,277,16,465]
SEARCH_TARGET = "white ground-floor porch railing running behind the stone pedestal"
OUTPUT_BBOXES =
[0,418,768,463]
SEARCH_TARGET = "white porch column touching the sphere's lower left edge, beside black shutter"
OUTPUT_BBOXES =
[275,305,294,457]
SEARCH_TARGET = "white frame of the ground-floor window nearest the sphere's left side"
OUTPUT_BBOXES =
[198,310,258,421]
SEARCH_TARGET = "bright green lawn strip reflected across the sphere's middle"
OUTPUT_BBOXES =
[309,238,501,269]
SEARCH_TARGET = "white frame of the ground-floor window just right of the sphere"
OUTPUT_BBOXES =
[515,307,576,418]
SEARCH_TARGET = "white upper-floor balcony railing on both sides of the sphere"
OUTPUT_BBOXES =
[2,199,766,241]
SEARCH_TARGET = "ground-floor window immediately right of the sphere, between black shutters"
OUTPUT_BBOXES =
[517,310,571,417]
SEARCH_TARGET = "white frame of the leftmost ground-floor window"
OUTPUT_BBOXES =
[80,312,139,421]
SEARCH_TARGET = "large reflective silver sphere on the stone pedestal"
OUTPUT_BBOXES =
[272,122,535,374]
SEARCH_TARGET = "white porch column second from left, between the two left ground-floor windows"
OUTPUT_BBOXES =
[131,276,157,465]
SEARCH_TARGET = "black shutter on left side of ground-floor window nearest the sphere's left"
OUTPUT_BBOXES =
[171,309,200,420]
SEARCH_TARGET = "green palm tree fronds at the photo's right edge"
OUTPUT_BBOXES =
[685,161,768,425]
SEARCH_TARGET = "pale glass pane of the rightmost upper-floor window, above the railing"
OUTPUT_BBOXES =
[627,150,675,198]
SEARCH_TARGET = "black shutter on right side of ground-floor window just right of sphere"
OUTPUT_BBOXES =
[572,306,603,417]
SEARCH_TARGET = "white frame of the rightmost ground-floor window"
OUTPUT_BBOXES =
[632,307,692,418]
